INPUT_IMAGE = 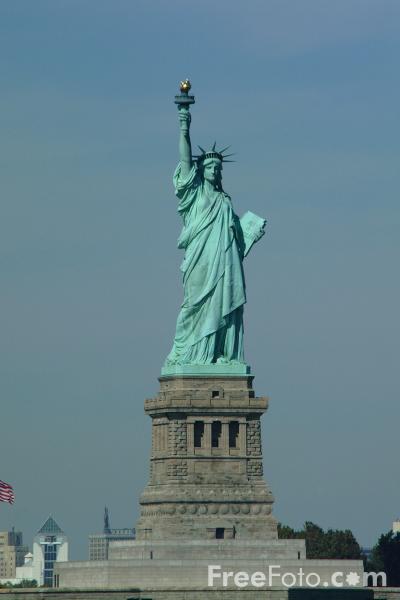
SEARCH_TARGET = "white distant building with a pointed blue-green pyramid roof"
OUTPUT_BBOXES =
[31,516,68,587]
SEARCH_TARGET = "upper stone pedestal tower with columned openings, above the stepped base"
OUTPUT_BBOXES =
[136,375,277,543]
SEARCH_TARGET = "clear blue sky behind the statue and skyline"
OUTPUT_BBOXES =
[0,0,400,559]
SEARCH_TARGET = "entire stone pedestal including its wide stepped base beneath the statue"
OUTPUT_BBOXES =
[55,373,363,600]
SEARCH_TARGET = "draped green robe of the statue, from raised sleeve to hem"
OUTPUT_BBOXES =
[166,164,246,365]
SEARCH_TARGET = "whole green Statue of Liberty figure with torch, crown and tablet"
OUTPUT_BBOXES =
[164,80,265,370]
